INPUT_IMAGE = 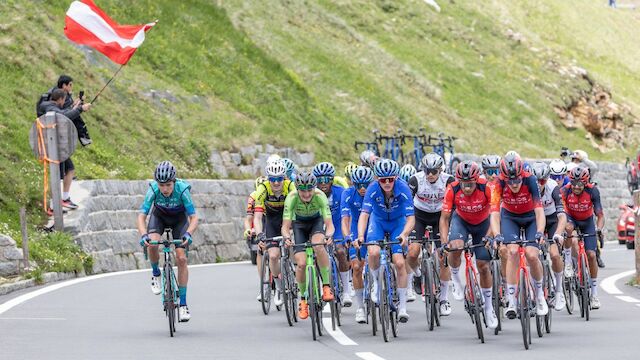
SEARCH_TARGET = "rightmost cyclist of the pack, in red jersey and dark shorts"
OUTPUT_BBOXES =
[561,166,604,309]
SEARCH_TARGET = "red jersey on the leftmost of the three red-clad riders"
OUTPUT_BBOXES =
[442,178,492,225]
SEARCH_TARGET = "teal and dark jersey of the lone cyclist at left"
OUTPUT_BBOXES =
[140,179,196,216]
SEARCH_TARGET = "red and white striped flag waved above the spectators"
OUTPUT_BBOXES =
[64,0,156,65]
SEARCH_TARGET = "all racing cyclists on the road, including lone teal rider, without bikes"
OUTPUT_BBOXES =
[131,144,604,329]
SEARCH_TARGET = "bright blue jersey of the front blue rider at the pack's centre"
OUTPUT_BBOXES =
[362,181,414,221]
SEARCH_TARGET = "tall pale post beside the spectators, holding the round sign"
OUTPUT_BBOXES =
[44,111,64,231]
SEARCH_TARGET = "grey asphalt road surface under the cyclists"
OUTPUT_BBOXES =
[0,243,640,360]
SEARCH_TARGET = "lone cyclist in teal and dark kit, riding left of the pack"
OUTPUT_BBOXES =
[138,161,198,322]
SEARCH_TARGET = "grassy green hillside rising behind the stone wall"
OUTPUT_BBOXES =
[0,0,640,228]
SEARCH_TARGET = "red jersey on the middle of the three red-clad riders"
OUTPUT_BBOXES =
[491,171,542,215]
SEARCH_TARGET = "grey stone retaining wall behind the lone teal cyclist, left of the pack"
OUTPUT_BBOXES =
[65,180,253,273]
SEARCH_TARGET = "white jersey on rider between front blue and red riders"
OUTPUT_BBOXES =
[409,171,454,213]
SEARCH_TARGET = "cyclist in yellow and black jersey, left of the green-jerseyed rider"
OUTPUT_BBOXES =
[253,159,295,306]
